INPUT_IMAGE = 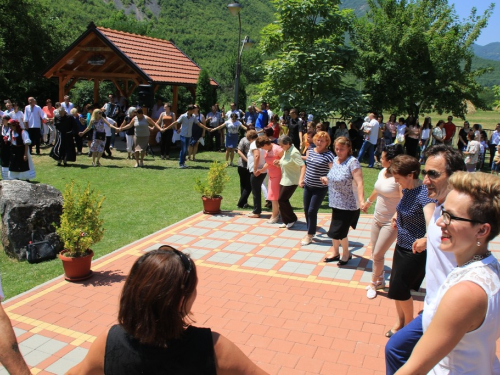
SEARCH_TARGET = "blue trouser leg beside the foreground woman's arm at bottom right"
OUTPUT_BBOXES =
[385,314,423,375]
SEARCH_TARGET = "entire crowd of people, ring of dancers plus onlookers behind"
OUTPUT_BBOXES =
[0,93,500,374]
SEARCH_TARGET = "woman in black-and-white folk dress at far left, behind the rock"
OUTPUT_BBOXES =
[8,120,36,181]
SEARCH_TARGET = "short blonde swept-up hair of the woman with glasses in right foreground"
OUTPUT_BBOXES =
[449,171,500,242]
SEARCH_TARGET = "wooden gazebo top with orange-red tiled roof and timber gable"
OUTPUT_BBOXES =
[43,23,218,112]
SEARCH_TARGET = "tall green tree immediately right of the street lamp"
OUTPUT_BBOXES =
[261,0,361,119]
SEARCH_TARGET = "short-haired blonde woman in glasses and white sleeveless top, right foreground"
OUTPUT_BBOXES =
[397,172,500,374]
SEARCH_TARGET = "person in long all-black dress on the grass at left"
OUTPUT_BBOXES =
[49,107,78,166]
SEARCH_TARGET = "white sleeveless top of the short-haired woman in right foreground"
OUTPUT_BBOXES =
[422,255,500,375]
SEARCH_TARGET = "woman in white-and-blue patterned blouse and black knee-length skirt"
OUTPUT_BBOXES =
[321,137,365,266]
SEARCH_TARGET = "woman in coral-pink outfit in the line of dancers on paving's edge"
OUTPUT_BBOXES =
[256,136,286,223]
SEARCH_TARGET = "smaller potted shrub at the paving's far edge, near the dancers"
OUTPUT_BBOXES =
[195,161,229,214]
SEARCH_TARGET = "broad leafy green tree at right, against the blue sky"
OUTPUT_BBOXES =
[352,0,493,117]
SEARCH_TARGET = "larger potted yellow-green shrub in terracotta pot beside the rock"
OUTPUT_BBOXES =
[56,181,104,281]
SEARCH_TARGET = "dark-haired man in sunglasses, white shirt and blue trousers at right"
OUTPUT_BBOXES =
[385,144,465,375]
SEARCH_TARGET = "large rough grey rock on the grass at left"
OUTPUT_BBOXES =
[0,180,63,259]
